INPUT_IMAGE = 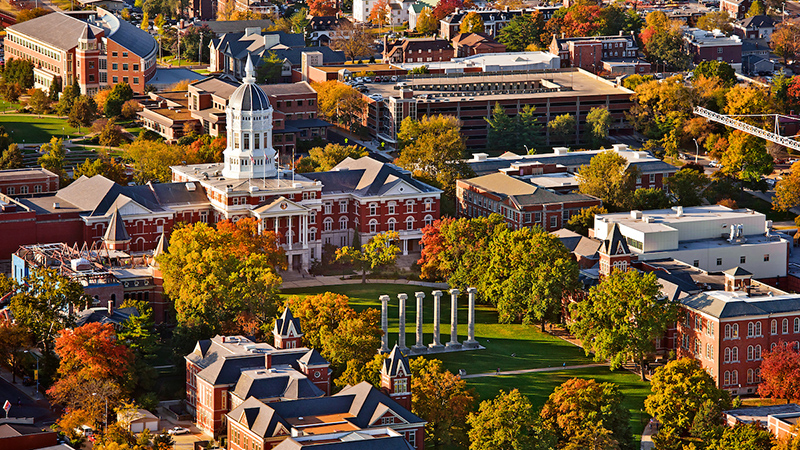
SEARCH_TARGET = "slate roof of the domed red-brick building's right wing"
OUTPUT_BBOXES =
[302,156,441,196]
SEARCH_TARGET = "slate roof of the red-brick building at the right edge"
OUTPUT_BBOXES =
[681,291,800,319]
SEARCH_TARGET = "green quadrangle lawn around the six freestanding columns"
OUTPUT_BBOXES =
[282,284,650,439]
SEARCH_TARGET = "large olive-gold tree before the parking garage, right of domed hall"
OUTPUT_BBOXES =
[397,115,472,197]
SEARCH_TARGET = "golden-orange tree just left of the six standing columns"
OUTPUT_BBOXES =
[286,292,383,372]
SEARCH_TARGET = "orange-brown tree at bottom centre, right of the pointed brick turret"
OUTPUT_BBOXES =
[411,358,475,448]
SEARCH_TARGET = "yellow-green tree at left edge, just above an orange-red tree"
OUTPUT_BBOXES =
[10,268,86,354]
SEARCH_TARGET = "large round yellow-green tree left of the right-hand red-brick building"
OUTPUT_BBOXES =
[569,269,678,380]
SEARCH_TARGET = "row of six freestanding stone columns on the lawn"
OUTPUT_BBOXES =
[380,287,479,354]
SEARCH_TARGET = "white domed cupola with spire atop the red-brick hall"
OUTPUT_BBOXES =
[222,57,277,179]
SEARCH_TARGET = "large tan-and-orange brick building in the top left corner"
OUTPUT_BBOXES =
[4,8,158,95]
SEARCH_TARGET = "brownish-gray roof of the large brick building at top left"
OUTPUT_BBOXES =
[8,12,103,50]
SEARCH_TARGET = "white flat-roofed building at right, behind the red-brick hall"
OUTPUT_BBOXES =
[593,205,790,279]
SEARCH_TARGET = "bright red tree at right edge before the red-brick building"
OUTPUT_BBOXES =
[758,342,800,401]
